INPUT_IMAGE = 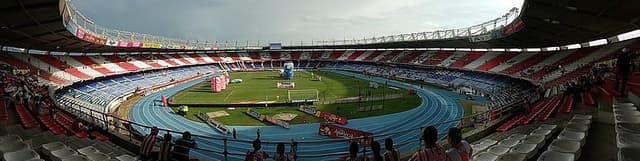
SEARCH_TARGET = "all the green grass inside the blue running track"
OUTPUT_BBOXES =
[170,71,482,126]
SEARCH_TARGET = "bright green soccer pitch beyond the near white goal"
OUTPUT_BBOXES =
[170,71,407,104]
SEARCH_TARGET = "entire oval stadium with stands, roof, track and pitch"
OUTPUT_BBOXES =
[0,0,640,161]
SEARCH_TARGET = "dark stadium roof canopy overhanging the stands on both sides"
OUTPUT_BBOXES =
[0,0,640,52]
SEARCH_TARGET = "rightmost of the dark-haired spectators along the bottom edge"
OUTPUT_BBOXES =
[447,128,473,161]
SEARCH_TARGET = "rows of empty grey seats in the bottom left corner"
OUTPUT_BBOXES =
[0,126,137,161]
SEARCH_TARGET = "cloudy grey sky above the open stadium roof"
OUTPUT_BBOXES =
[72,0,523,42]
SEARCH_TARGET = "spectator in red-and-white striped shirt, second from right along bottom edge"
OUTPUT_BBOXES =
[409,126,450,161]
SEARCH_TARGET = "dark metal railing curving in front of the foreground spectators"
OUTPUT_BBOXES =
[56,70,515,160]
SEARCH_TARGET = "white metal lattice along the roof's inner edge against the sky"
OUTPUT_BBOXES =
[61,0,520,50]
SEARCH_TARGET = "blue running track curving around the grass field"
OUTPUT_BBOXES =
[129,71,465,161]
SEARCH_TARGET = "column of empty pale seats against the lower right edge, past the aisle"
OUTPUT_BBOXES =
[613,99,640,161]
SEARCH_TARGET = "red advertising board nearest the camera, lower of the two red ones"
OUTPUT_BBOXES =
[318,122,373,143]
